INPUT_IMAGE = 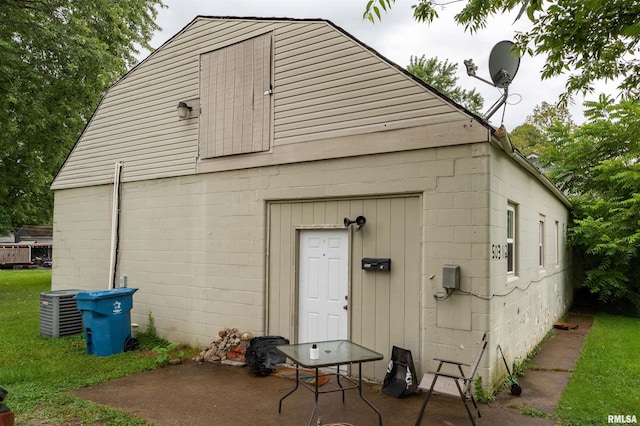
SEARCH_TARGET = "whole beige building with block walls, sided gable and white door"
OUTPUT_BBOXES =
[52,16,572,387]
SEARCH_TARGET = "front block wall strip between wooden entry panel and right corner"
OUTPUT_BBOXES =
[421,143,490,380]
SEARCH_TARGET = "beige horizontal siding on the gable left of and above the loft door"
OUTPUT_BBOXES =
[52,18,292,189]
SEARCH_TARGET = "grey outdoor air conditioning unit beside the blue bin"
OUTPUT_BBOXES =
[40,290,82,338]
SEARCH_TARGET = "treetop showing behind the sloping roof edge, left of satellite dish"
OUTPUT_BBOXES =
[407,55,484,113]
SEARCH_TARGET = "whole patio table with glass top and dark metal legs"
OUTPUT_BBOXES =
[277,340,383,426]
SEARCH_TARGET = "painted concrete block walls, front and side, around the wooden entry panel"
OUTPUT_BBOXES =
[54,143,568,390]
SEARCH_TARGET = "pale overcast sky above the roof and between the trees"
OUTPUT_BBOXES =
[142,0,606,131]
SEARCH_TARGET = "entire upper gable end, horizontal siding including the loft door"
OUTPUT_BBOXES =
[52,16,491,189]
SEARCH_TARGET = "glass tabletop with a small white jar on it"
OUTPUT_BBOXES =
[277,340,383,368]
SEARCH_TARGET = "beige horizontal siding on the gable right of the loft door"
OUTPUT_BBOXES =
[274,26,461,146]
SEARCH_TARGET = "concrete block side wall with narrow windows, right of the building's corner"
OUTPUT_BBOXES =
[488,148,572,383]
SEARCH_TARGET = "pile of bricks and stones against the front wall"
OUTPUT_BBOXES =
[194,328,253,366]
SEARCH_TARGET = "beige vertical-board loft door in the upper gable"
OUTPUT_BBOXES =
[198,33,272,158]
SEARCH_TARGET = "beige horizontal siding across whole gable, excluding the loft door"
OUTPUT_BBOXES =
[52,17,470,189]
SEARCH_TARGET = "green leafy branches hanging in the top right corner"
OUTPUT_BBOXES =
[519,0,640,103]
